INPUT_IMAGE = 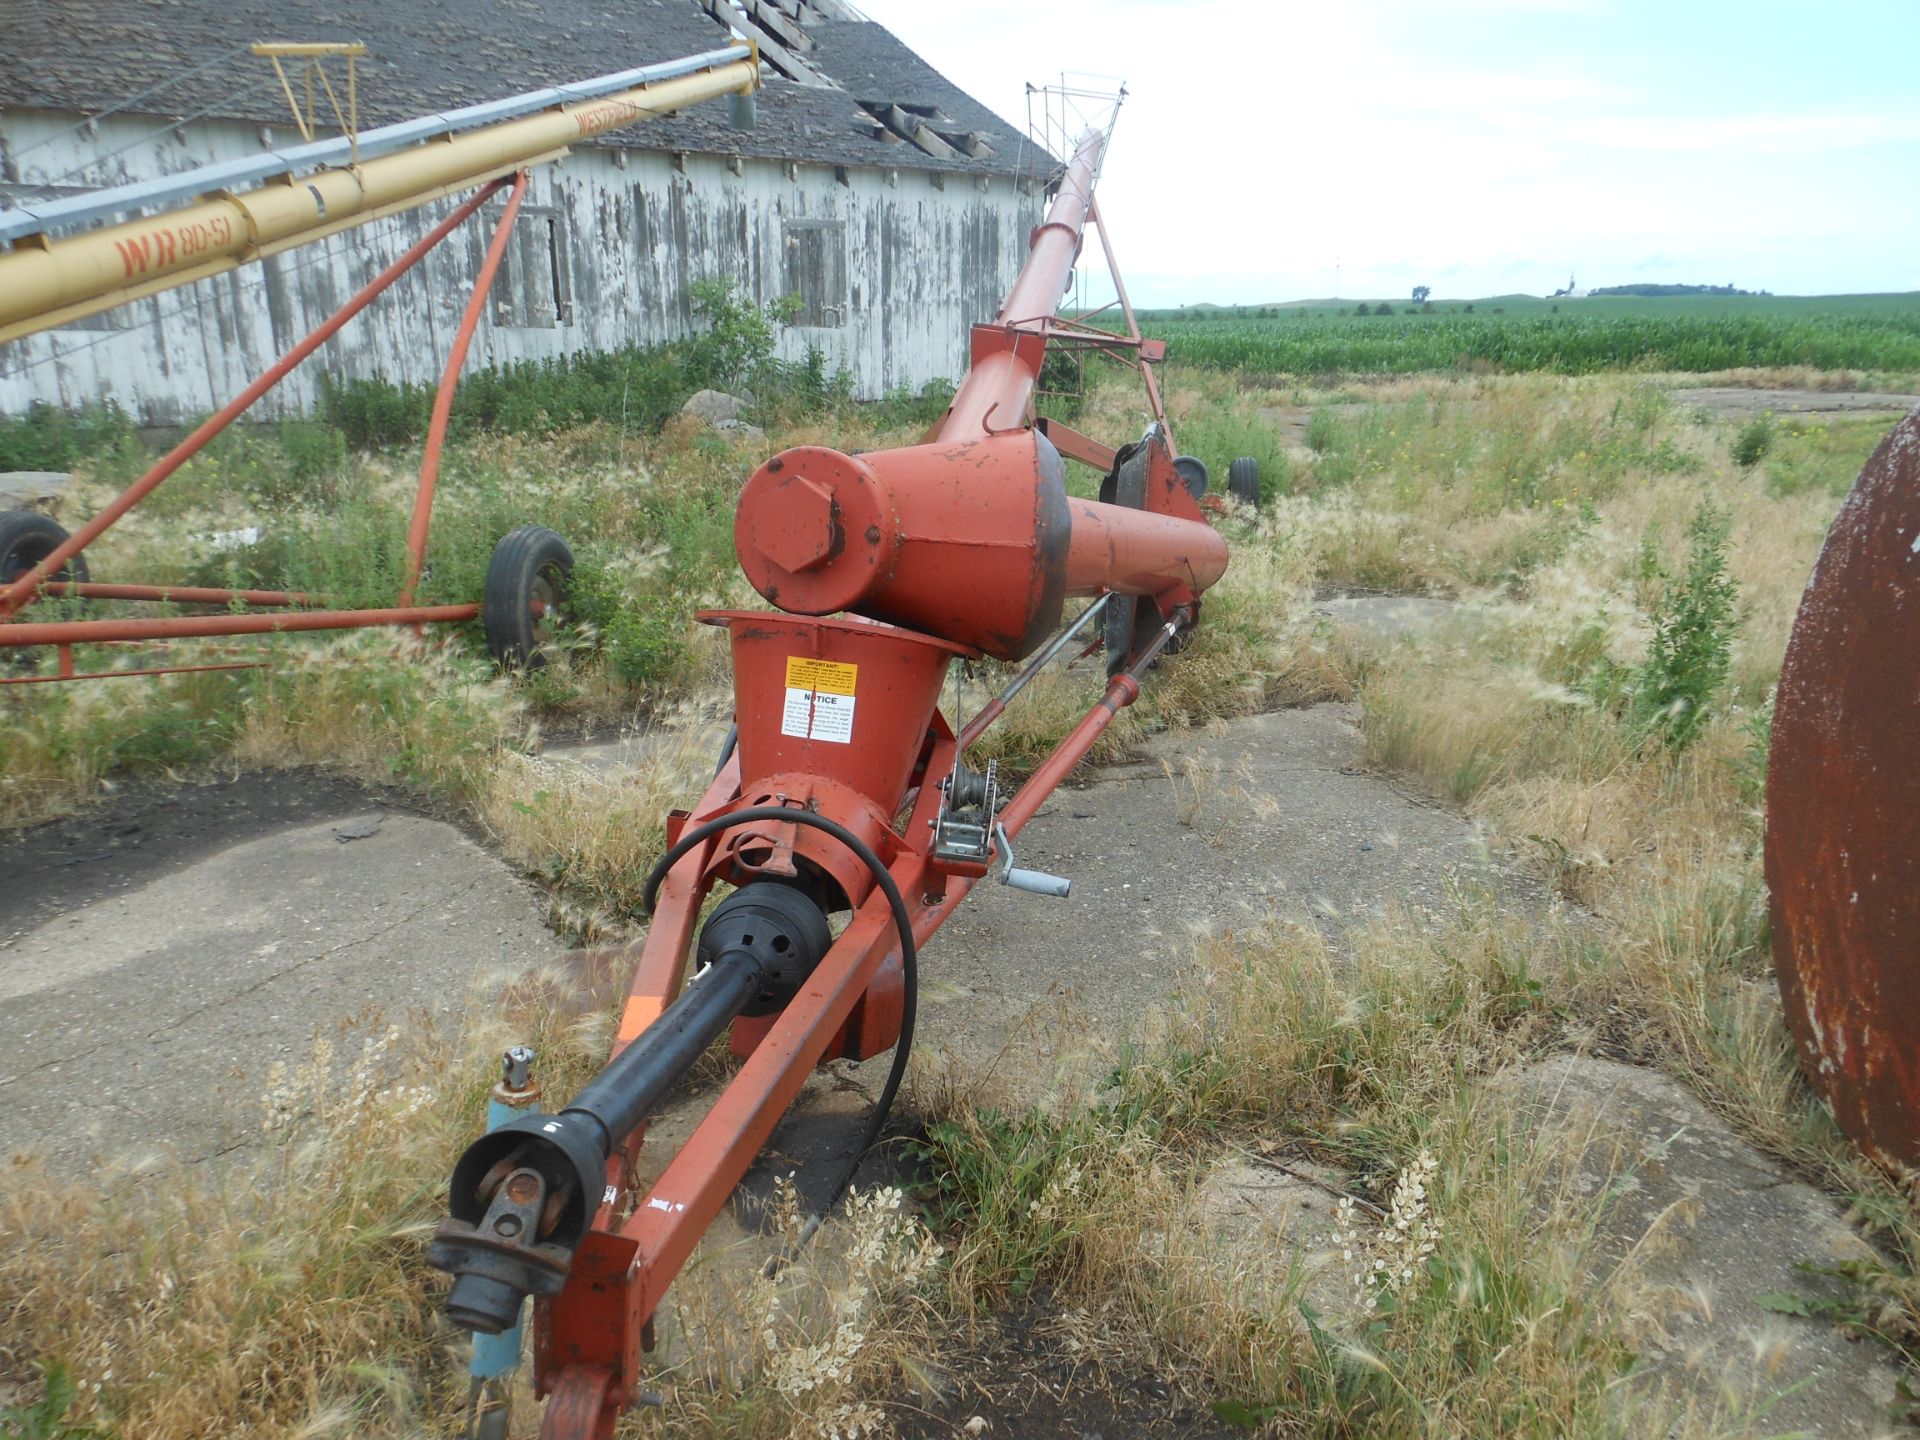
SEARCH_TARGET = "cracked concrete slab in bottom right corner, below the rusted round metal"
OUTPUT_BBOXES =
[1498,1056,1901,1440]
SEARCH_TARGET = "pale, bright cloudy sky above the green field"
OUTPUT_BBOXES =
[854,0,1920,305]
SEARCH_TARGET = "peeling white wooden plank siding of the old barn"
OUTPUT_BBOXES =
[0,111,1039,422]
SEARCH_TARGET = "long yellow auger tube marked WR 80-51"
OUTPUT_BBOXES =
[0,52,758,342]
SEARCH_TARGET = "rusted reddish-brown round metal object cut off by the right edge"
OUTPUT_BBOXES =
[1766,411,1920,1165]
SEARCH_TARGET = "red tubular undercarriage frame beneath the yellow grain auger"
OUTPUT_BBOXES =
[0,171,528,685]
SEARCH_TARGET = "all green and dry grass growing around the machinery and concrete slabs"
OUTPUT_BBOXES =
[0,360,1920,1436]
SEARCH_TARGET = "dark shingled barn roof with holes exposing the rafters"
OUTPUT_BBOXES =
[0,0,1050,175]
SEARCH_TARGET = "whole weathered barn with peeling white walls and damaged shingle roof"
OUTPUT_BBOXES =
[0,0,1046,422]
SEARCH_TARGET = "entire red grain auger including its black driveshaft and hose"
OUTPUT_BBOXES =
[430,115,1252,1436]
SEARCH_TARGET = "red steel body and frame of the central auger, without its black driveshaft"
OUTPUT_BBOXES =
[518,115,1225,1440]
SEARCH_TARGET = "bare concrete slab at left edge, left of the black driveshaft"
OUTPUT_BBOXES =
[0,808,559,1171]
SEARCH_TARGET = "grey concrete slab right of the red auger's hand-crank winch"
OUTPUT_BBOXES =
[920,705,1549,1100]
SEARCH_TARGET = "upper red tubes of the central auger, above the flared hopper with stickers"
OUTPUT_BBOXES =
[733,122,1227,660]
